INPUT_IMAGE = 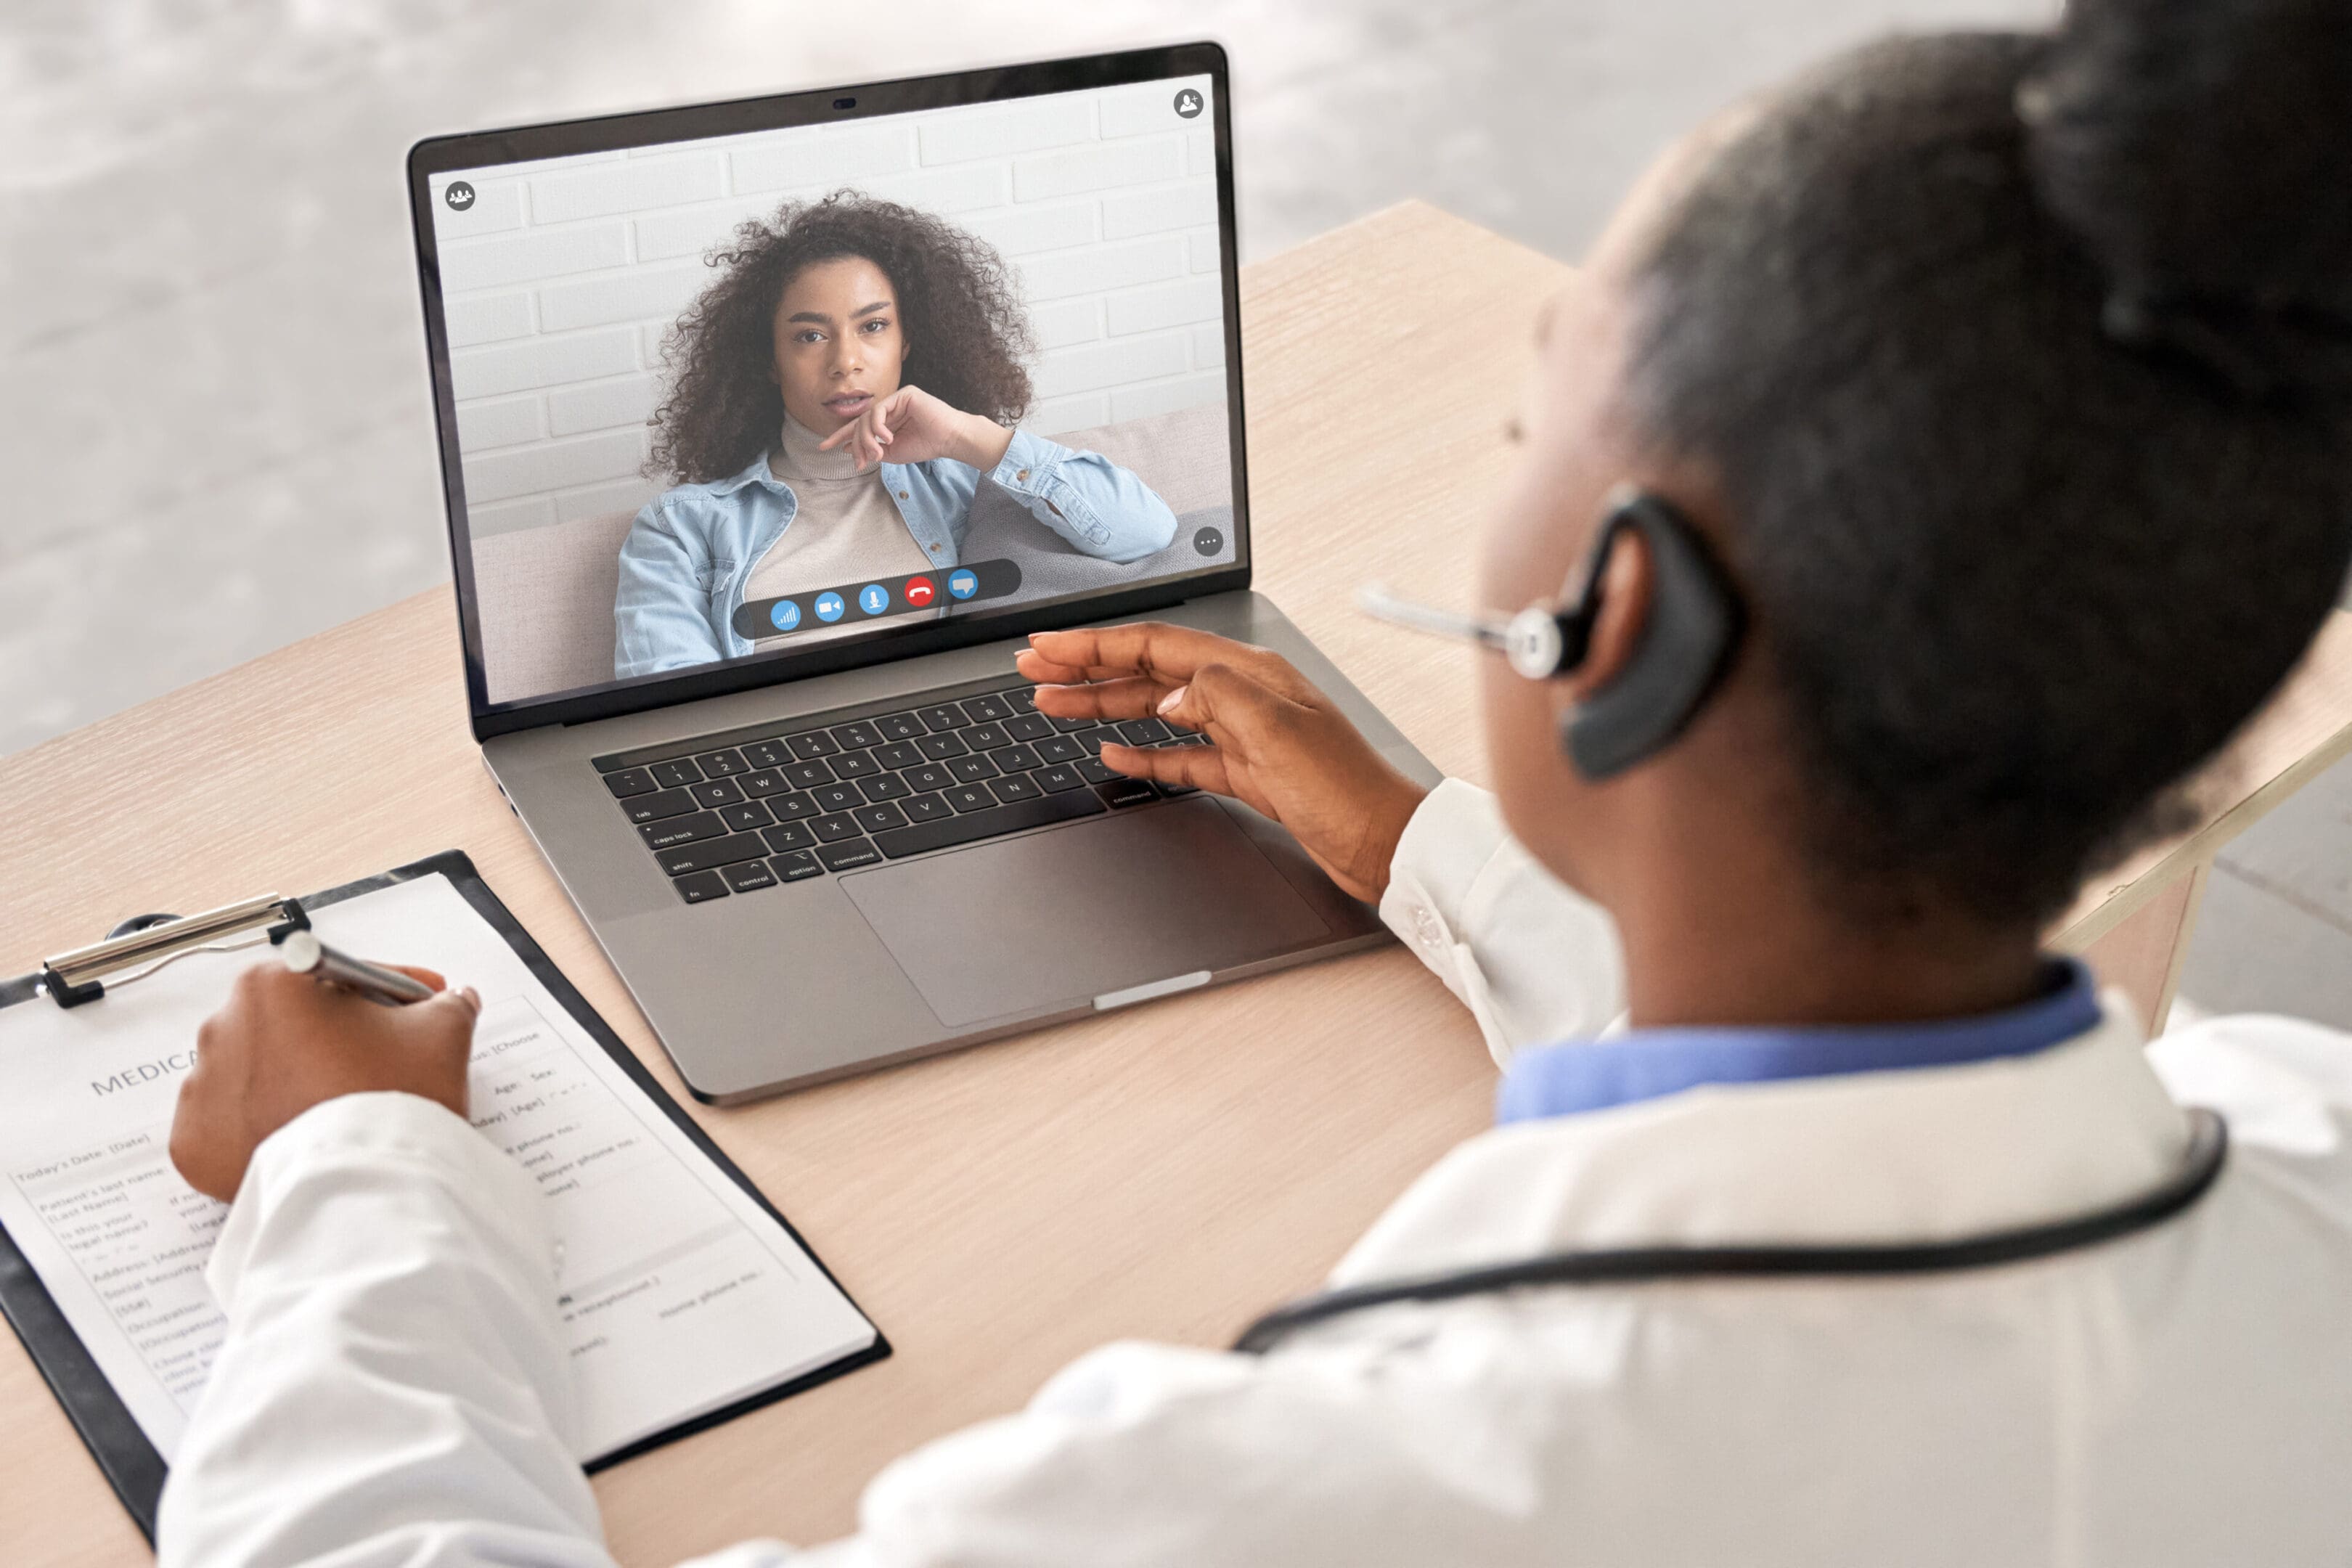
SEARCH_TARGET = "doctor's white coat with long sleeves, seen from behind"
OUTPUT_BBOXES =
[158,783,2352,1568]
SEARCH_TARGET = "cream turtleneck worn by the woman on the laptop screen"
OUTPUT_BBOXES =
[743,414,931,653]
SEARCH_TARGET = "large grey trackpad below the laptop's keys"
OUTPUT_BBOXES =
[842,799,1329,1027]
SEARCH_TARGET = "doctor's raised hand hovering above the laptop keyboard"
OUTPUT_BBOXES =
[1016,621,1425,900]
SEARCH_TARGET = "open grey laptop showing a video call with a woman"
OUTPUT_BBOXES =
[409,45,1437,1103]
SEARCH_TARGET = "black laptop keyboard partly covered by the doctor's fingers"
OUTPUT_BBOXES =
[597,682,1206,903]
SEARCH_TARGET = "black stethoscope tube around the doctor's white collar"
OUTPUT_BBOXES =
[1233,1110,2230,1357]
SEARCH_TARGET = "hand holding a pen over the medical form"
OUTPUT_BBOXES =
[172,961,482,1204]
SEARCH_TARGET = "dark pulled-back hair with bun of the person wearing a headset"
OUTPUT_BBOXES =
[1628,0,2352,926]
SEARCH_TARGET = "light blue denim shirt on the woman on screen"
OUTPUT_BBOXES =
[611,430,1176,677]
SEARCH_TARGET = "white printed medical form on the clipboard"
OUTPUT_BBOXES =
[0,875,880,1462]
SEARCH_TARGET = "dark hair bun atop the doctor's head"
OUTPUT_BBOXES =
[2018,0,2352,393]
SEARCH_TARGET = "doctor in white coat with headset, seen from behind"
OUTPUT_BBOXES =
[160,0,2352,1568]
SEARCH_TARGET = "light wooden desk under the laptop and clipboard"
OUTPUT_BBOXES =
[0,205,2352,1564]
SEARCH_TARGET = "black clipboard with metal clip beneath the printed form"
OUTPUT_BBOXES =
[0,849,891,1545]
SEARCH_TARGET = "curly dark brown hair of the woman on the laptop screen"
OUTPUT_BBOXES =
[645,190,1032,484]
